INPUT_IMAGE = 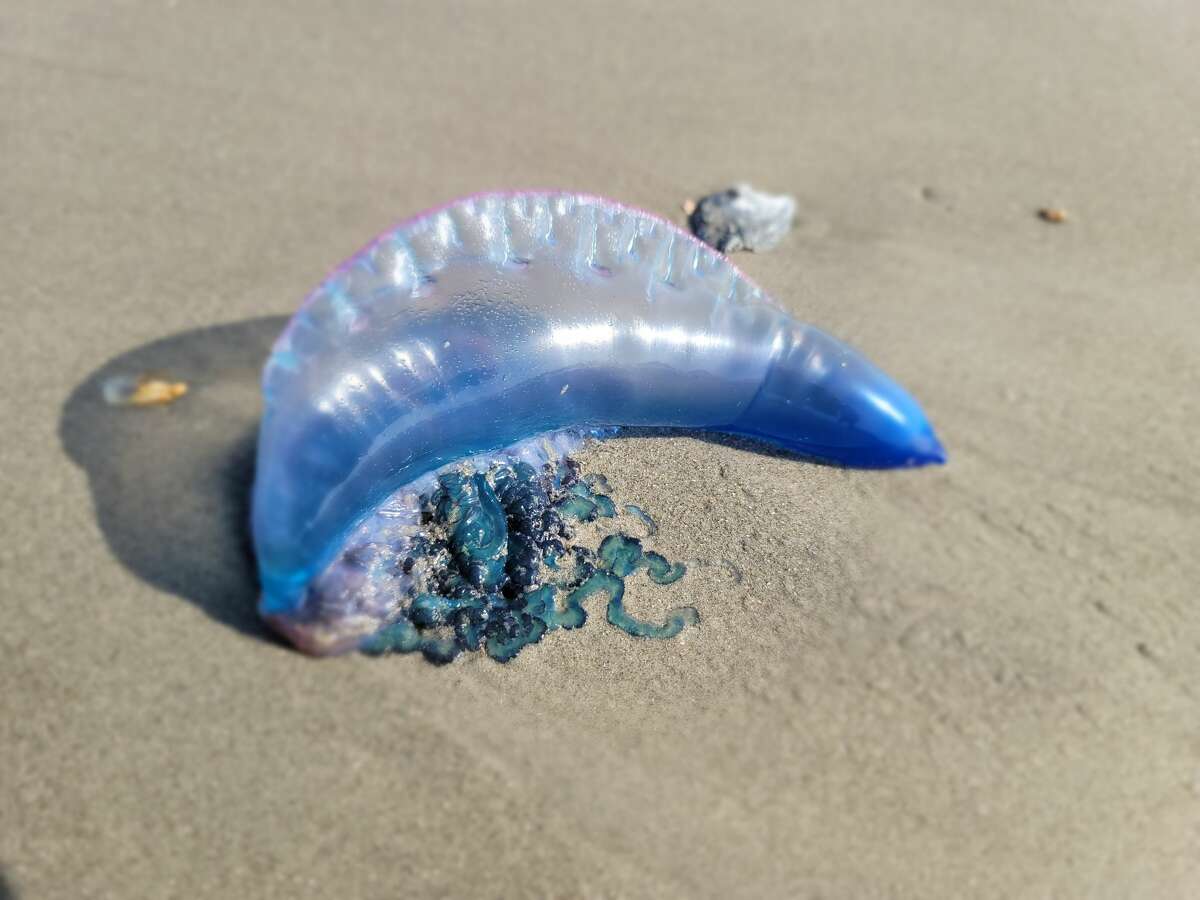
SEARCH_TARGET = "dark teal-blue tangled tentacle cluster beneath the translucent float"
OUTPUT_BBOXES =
[349,457,700,662]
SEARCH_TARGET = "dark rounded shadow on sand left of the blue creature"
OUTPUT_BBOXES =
[59,317,287,640]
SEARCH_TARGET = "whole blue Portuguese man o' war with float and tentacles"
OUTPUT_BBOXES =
[252,191,944,661]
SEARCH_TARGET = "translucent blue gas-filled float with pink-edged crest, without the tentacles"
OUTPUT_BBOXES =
[253,192,943,652]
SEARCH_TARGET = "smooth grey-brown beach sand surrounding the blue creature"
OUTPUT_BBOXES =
[0,0,1200,898]
